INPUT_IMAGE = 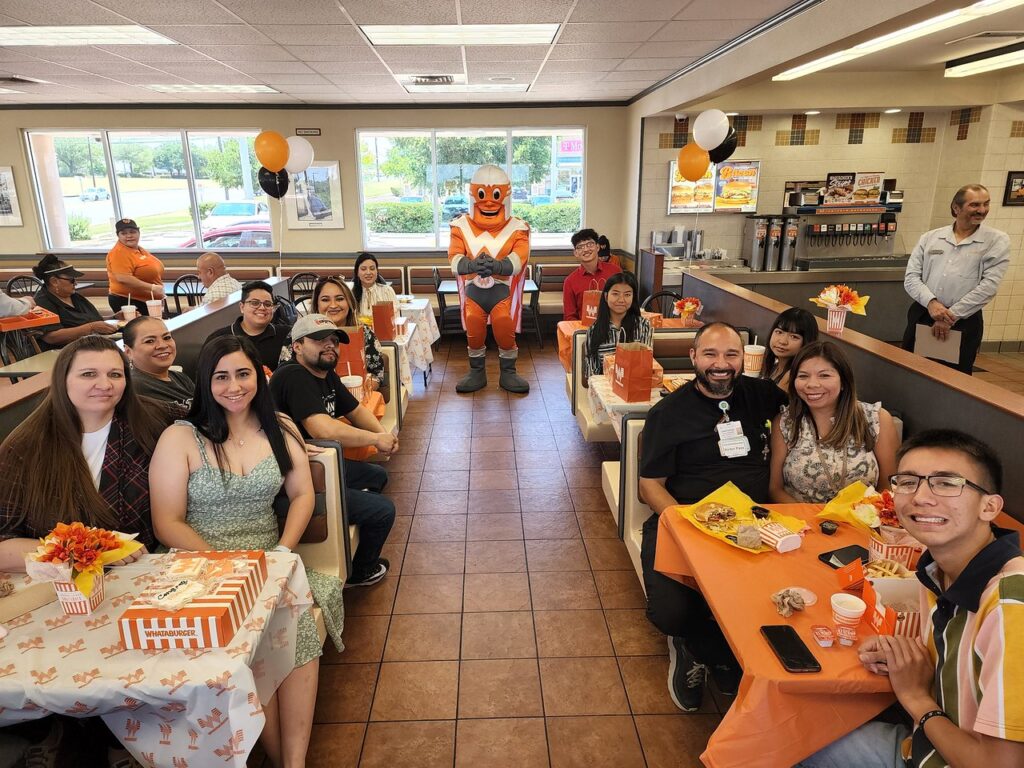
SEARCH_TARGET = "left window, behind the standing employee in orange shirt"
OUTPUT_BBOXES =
[28,130,271,251]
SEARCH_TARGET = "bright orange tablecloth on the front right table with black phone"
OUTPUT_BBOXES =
[654,504,895,768]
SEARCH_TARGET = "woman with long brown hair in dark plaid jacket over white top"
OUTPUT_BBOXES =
[0,336,170,571]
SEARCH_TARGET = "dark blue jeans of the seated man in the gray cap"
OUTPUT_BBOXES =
[345,461,395,581]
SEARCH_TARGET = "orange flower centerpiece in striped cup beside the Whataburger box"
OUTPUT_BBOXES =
[25,522,142,613]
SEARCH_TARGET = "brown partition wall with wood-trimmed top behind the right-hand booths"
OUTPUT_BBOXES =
[683,270,1024,521]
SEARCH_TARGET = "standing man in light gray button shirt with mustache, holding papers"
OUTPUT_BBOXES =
[902,184,1010,374]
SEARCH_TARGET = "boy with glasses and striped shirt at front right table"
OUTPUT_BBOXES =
[801,429,1024,768]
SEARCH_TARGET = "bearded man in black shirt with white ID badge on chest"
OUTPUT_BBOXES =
[640,323,786,712]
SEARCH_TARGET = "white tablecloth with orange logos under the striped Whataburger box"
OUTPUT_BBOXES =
[0,552,312,768]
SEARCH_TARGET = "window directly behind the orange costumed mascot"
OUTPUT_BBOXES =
[358,128,584,250]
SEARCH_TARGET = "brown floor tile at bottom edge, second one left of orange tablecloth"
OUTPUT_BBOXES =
[547,717,644,768]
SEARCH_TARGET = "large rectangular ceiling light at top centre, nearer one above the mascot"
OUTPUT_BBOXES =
[359,23,557,45]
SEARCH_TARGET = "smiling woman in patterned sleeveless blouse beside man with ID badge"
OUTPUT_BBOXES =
[769,341,898,504]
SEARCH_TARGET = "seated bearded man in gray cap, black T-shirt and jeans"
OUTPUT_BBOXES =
[270,314,398,587]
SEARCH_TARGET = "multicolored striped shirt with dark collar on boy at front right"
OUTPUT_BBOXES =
[908,526,1024,768]
